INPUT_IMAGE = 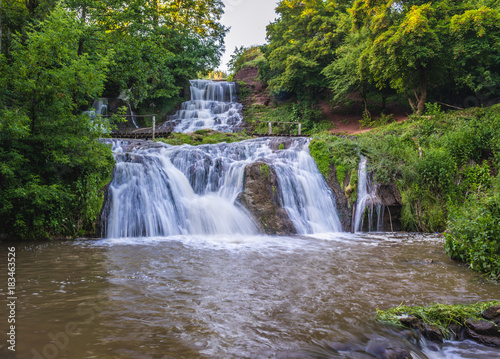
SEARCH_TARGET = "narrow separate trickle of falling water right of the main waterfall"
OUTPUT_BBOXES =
[354,156,385,232]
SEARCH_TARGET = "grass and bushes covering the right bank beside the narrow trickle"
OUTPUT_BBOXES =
[311,105,500,279]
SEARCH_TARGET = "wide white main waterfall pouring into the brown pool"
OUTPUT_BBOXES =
[103,138,341,238]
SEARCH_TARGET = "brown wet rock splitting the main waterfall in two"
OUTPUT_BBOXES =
[238,162,297,235]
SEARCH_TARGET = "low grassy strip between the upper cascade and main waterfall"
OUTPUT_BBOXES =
[156,130,253,146]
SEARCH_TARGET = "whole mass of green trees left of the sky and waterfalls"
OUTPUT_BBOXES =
[0,0,226,239]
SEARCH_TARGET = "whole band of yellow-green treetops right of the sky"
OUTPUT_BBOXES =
[241,0,500,115]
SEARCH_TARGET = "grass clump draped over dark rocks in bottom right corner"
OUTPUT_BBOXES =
[375,301,500,339]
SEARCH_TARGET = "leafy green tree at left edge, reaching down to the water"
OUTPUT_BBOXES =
[0,7,113,238]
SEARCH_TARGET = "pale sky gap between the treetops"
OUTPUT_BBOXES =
[220,0,278,71]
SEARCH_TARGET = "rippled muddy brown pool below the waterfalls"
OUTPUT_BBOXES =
[0,234,500,359]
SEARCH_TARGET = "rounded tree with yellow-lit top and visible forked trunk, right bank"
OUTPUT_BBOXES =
[366,4,451,114]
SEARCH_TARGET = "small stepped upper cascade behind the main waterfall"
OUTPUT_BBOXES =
[166,80,243,133]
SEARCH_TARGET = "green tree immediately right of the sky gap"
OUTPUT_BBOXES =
[266,0,346,99]
